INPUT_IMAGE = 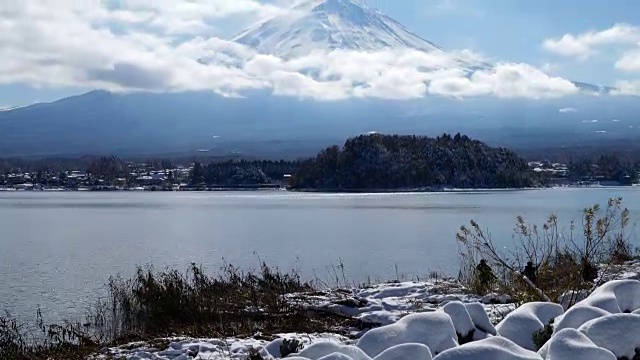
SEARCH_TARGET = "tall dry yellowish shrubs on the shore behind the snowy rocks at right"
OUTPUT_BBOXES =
[457,198,633,306]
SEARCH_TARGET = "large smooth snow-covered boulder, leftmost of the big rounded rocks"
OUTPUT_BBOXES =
[357,312,458,357]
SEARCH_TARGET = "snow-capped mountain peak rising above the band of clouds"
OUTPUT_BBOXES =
[233,0,440,58]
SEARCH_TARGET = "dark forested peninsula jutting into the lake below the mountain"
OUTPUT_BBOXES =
[290,134,540,191]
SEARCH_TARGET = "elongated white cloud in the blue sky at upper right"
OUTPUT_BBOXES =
[542,24,640,59]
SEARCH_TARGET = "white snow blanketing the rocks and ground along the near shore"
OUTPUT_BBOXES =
[93,271,640,360]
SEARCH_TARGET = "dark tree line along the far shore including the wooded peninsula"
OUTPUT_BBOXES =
[0,134,640,191]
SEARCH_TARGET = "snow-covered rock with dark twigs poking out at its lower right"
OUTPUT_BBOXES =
[496,302,564,351]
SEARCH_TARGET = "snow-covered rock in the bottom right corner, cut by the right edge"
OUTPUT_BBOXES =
[578,314,640,359]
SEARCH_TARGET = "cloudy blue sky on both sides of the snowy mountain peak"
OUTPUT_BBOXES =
[0,0,640,107]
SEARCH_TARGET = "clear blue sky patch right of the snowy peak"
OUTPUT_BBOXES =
[380,0,640,85]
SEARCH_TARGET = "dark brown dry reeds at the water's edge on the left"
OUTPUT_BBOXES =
[0,264,361,360]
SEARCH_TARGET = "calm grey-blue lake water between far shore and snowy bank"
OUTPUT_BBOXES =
[0,187,640,317]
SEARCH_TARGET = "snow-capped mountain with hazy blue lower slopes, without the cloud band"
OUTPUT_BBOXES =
[0,0,640,157]
